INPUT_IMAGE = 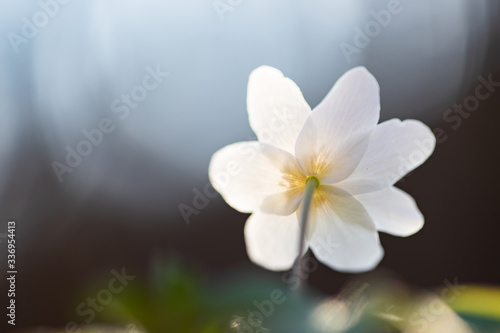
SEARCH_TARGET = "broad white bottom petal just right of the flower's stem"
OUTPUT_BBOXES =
[309,185,384,272]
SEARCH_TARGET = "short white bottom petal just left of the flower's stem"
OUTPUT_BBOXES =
[245,211,300,271]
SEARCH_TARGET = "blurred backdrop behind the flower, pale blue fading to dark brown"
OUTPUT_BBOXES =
[0,0,500,328]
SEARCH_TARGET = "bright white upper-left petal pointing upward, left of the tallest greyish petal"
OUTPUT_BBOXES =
[247,66,311,154]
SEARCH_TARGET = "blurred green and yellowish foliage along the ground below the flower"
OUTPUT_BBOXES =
[26,259,500,333]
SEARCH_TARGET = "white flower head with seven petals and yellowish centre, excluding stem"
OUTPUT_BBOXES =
[209,66,435,272]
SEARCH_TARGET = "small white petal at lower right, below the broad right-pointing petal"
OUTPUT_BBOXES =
[356,186,424,237]
